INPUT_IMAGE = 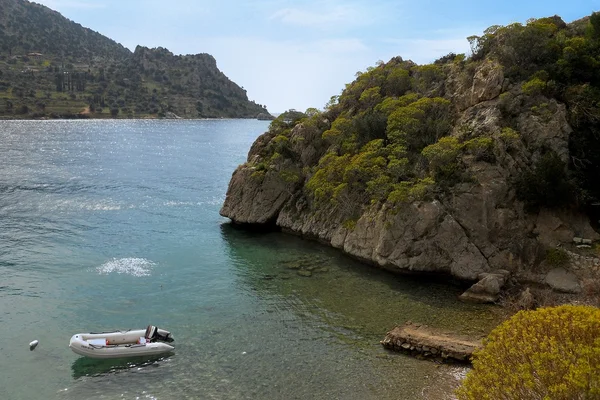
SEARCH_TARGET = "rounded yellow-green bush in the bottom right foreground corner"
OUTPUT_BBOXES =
[457,305,600,400]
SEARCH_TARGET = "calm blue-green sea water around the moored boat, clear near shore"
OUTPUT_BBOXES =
[0,120,498,399]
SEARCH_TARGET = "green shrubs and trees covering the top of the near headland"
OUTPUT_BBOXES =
[263,14,600,221]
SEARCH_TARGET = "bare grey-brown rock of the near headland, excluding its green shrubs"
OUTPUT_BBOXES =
[221,61,600,288]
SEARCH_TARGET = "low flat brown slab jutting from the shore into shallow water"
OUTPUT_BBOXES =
[381,322,482,362]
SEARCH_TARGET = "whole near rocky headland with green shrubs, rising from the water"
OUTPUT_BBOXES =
[221,17,600,297]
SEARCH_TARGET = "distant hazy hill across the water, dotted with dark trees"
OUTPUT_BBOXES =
[0,0,269,118]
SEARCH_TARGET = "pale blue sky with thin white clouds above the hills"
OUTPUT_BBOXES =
[35,0,600,113]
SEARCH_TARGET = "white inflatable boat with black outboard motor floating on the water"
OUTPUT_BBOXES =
[69,325,175,358]
